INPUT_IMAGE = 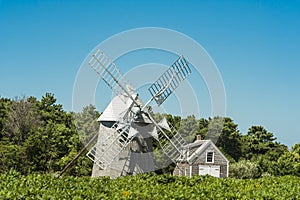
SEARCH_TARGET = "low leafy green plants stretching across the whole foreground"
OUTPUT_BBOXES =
[0,171,300,199]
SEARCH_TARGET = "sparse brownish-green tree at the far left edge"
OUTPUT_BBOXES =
[0,97,40,173]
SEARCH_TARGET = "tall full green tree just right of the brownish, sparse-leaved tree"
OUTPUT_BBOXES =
[24,93,77,172]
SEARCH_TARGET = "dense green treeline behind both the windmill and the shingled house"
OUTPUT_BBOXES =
[0,93,300,178]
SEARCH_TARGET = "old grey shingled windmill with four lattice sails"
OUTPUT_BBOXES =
[61,49,191,178]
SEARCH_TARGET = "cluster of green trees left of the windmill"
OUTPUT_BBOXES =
[0,93,99,176]
